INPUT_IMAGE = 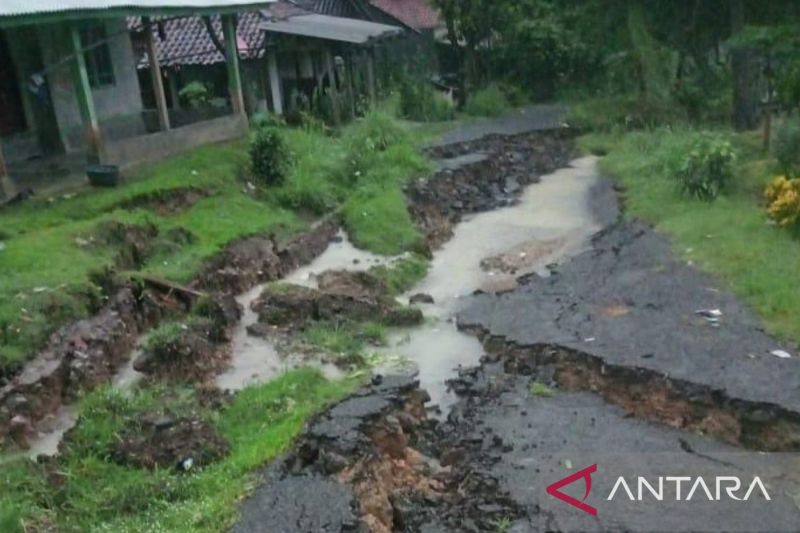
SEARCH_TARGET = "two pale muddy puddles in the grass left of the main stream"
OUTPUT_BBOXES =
[216,232,393,390]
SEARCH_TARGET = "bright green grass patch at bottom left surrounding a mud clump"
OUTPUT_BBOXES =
[0,370,354,532]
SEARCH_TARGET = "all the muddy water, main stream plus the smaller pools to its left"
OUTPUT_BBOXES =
[23,157,599,456]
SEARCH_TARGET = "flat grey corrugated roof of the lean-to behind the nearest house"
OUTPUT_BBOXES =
[261,14,403,44]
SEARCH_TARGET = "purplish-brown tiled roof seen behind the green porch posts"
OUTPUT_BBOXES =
[128,2,308,68]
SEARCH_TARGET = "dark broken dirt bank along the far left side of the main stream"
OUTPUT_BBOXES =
[406,131,571,249]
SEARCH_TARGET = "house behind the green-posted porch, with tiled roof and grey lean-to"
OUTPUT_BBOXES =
[133,0,403,127]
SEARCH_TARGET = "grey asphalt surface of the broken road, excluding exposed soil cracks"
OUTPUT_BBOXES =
[234,110,800,533]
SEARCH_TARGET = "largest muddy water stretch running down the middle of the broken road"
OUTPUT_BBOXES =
[386,157,600,413]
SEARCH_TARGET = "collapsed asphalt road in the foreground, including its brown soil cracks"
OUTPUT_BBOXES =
[234,111,800,533]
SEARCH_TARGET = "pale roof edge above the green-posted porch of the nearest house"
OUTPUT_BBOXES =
[0,0,275,18]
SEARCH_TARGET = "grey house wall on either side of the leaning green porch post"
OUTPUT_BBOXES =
[37,19,145,152]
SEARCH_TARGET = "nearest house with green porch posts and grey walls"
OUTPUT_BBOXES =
[0,0,274,196]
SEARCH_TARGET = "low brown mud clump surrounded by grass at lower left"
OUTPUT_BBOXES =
[112,414,230,470]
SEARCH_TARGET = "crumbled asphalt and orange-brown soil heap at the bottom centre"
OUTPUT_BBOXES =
[234,377,518,533]
